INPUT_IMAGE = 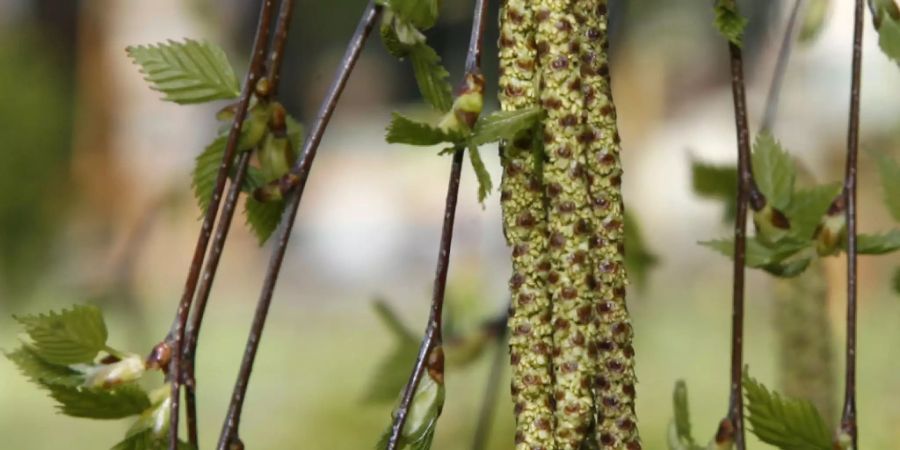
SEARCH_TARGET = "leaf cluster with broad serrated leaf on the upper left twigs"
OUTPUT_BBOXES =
[127,39,302,244]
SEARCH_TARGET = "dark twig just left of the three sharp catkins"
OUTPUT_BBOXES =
[386,0,487,450]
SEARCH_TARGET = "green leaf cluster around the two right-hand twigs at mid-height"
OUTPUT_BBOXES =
[692,133,900,277]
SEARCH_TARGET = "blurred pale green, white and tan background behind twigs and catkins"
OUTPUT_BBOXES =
[0,0,900,450]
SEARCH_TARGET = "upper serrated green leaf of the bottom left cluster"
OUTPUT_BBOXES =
[14,305,107,365]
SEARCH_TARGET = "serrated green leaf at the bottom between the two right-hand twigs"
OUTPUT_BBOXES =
[744,371,832,450]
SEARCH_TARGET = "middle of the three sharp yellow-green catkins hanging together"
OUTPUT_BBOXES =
[534,0,594,450]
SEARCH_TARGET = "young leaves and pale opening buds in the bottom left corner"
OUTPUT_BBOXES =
[6,305,190,450]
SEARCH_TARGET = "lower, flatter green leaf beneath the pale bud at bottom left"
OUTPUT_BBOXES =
[45,383,150,419]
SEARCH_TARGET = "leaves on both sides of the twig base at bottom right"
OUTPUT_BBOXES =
[667,369,843,450]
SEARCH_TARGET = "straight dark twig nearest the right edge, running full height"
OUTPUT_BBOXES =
[840,0,865,449]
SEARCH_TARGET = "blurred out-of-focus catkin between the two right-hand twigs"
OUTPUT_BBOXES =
[773,261,837,421]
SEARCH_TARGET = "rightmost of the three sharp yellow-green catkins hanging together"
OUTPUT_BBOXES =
[575,0,641,450]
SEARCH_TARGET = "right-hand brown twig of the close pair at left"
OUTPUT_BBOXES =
[183,0,294,447]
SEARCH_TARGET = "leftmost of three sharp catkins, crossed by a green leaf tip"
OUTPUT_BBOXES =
[499,0,555,450]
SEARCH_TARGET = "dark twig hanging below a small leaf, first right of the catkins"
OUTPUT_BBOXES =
[728,38,752,450]
